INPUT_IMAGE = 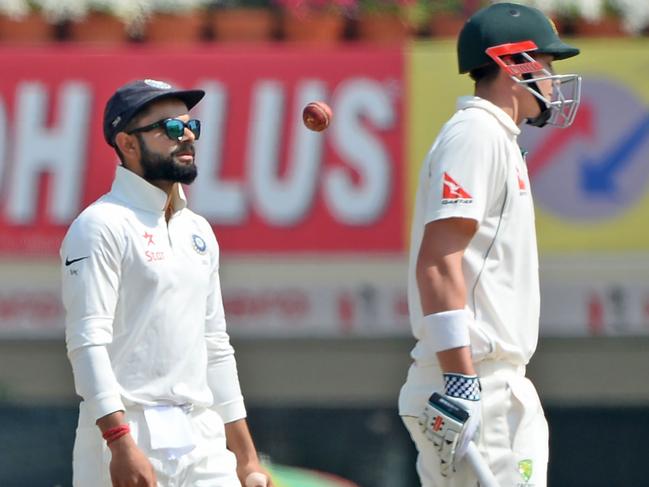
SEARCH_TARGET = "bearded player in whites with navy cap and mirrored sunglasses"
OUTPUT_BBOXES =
[61,80,272,487]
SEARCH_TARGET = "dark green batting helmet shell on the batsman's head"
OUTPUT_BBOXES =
[457,3,579,73]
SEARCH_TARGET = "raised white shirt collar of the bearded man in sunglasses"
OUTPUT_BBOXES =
[111,166,187,213]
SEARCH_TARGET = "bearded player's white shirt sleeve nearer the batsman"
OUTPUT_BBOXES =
[205,228,246,423]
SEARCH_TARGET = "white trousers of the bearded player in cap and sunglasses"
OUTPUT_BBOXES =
[72,403,241,487]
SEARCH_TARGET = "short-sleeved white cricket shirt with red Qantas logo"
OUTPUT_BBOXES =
[401,96,540,415]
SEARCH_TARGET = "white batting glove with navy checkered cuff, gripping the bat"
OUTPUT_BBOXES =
[419,374,482,477]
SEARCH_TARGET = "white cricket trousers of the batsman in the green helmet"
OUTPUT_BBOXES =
[402,362,549,487]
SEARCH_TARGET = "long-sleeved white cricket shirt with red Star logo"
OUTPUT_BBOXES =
[61,166,246,423]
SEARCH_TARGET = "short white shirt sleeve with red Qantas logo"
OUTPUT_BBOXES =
[423,120,505,226]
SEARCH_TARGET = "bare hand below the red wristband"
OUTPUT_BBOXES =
[109,435,157,487]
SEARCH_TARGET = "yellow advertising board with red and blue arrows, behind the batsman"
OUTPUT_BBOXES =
[408,39,649,252]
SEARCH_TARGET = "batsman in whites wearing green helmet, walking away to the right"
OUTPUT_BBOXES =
[399,3,581,487]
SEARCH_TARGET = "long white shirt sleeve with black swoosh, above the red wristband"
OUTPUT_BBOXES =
[61,210,124,419]
